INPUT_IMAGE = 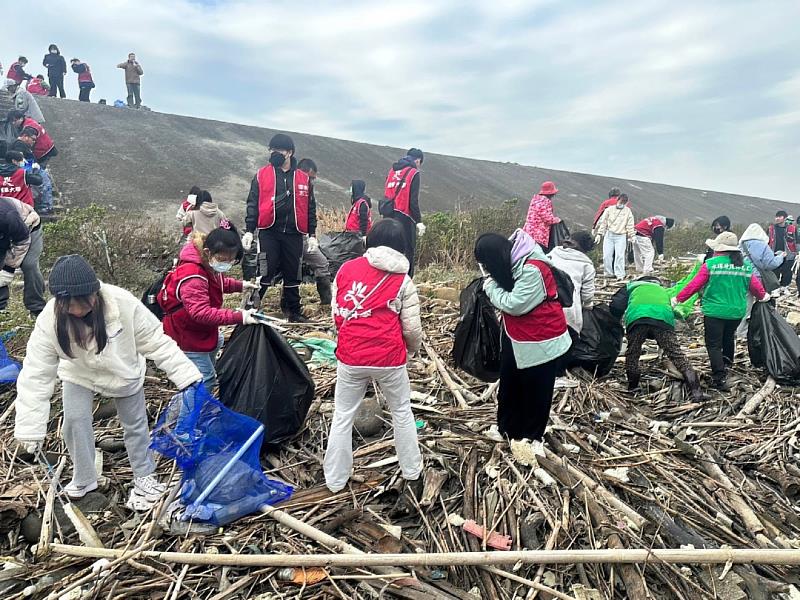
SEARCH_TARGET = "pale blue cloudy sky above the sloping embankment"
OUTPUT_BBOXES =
[0,0,800,202]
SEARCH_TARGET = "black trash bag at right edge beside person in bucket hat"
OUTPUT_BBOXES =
[747,302,800,385]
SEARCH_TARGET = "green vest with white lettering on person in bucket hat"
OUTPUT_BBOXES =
[703,255,753,320]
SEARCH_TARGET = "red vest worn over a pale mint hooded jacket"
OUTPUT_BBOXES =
[503,260,567,342]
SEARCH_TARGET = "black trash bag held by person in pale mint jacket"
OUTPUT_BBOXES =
[453,278,500,382]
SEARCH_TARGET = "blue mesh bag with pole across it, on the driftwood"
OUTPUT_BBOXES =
[150,385,293,525]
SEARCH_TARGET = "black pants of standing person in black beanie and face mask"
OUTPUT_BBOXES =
[258,229,303,315]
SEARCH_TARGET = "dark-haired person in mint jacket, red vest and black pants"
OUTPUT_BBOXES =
[475,229,572,455]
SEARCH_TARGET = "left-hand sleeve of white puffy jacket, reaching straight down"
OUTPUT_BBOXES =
[14,314,59,442]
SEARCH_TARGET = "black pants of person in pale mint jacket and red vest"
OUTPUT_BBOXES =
[497,332,558,440]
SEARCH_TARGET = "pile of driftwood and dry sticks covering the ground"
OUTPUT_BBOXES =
[0,264,800,600]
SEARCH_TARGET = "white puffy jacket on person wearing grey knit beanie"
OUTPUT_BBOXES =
[14,284,203,441]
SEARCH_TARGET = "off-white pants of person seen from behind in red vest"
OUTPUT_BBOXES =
[323,363,422,492]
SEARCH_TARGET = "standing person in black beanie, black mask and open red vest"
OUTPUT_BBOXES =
[242,133,319,323]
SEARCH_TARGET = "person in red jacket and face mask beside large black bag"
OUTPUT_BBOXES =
[158,221,257,390]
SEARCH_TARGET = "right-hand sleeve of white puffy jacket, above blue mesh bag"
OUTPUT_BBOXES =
[133,298,203,390]
